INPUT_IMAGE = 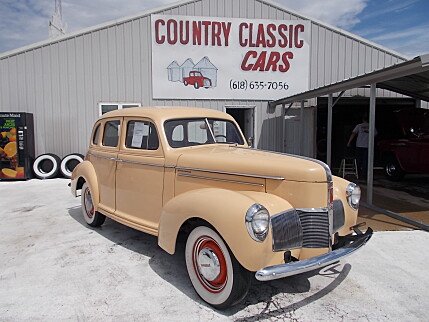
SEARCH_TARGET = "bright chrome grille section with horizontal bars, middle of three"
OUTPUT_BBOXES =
[298,211,329,248]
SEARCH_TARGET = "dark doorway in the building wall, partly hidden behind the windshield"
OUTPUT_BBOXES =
[225,106,256,147]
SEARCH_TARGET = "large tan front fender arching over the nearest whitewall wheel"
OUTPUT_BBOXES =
[158,188,297,271]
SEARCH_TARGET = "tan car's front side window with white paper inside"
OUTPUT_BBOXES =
[125,121,159,150]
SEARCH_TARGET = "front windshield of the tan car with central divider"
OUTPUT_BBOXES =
[164,118,244,148]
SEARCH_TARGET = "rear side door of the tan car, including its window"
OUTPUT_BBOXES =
[90,118,122,213]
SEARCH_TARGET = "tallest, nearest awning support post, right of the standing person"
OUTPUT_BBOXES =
[366,84,377,205]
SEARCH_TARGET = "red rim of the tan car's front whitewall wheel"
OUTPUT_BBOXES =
[192,236,228,293]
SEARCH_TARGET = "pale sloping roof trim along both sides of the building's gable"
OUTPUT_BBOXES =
[0,0,404,60]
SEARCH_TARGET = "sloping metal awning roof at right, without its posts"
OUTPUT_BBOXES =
[269,54,429,107]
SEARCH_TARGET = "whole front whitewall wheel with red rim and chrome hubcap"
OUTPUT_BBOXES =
[185,226,251,309]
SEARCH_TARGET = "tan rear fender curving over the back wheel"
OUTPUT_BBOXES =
[71,160,100,210]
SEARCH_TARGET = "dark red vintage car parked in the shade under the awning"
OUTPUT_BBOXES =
[379,108,429,180]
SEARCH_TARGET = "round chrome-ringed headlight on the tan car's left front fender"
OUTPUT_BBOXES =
[246,203,270,242]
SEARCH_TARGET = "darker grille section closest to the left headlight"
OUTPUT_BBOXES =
[271,209,302,252]
